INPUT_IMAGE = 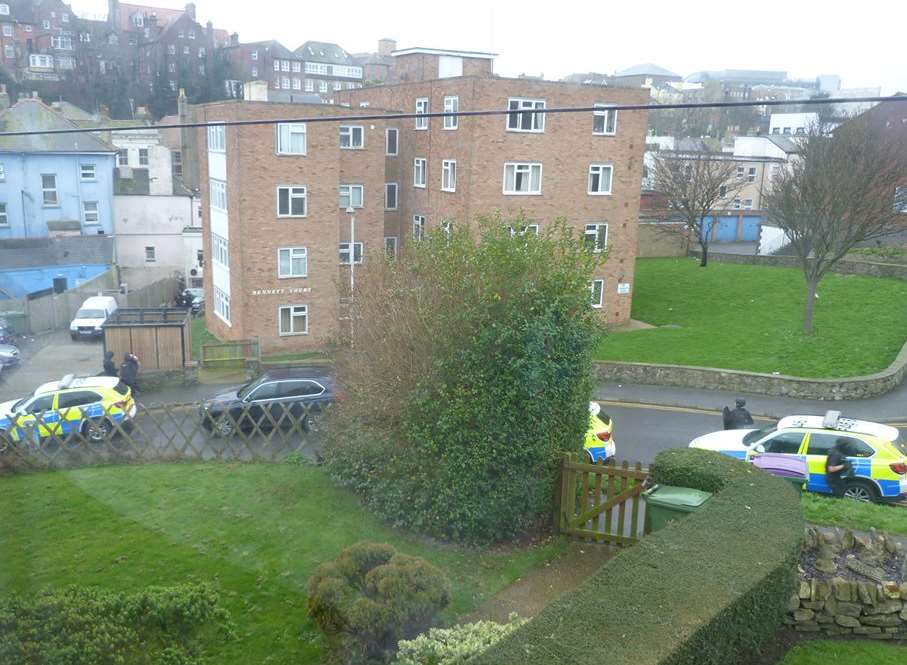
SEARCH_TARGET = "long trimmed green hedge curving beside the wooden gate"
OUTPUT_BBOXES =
[475,449,804,665]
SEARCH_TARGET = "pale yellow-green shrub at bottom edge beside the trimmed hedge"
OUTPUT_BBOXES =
[394,614,526,665]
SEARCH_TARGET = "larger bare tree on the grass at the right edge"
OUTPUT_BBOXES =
[763,114,907,334]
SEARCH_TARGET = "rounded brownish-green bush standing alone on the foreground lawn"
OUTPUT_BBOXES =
[307,542,450,663]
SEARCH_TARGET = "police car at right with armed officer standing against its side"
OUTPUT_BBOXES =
[690,411,907,501]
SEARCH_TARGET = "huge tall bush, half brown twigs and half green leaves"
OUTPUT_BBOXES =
[325,219,599,542]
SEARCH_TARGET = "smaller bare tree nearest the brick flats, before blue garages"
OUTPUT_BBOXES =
[653,146,745,268]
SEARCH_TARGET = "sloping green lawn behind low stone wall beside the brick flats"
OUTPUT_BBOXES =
[595,258,907,378]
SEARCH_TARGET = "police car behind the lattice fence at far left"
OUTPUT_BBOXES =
[0,374,136,451]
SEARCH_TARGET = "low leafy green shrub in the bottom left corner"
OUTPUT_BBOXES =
[0,584,232,665]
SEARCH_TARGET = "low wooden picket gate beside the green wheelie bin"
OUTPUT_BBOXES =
[558,454,649,545]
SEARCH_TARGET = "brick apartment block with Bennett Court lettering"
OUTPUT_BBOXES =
[195,49,647,351]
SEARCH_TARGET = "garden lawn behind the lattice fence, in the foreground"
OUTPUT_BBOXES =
[0,463,564,664]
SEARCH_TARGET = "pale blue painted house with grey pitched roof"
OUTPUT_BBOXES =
[0,98,116,240]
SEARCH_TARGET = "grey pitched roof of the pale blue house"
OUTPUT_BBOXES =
[0,97,116,152]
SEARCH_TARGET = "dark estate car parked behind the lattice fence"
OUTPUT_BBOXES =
[199,368,336,436]
